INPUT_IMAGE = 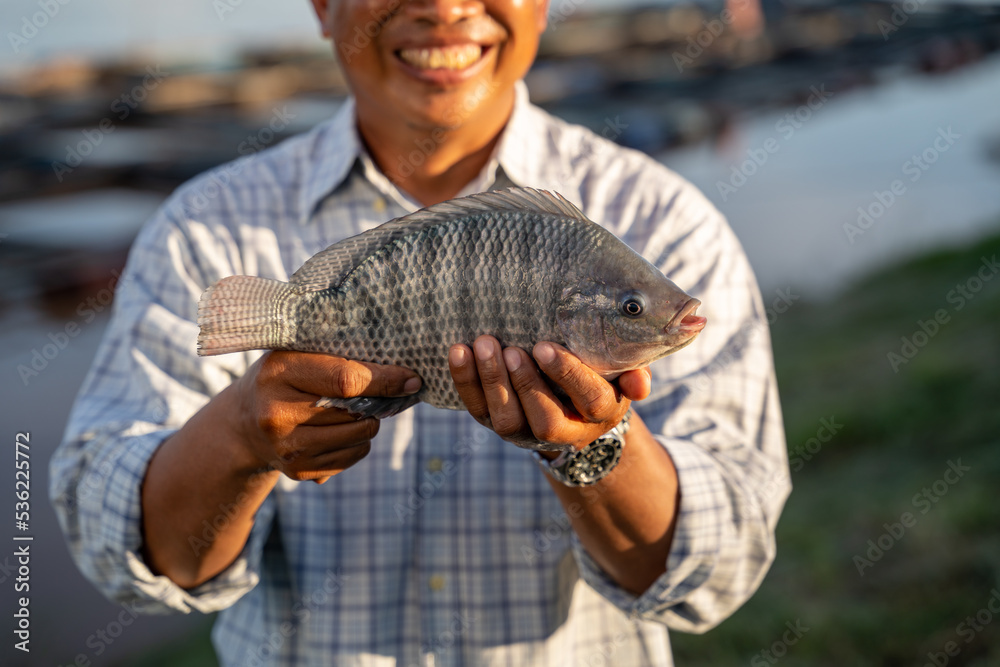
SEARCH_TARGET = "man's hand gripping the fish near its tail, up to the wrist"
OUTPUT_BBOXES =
[231,352,420,484]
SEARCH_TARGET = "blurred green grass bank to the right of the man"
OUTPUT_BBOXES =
[673,228,1000,666]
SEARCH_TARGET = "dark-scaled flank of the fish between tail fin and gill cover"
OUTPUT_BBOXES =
[296,214,587,409]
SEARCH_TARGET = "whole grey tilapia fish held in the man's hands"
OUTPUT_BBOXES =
[198,188,707,449]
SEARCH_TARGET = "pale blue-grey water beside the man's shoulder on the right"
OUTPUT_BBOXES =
[661,56,1000,297]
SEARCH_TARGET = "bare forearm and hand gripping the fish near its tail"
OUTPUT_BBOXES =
[142,352,420,588]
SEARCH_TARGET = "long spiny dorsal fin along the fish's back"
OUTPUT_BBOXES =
[289,188,587,292]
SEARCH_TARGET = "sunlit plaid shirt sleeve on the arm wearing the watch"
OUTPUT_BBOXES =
[573,179,791,633]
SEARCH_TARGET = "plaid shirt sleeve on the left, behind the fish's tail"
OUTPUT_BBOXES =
[49,207,274,613]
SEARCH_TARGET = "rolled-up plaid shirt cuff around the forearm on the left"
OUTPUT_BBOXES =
[73,431,274,613]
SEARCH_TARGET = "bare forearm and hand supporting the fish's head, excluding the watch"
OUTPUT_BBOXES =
[448,336,680,595]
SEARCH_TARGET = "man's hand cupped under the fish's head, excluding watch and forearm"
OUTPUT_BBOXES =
[448,336,650,449]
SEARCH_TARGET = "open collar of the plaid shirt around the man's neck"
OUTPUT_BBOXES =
[299,81,551,223]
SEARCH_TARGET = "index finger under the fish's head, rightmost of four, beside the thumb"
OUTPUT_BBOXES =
[532,342,620,423]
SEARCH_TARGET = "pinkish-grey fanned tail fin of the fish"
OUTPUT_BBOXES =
[198,276,296,356]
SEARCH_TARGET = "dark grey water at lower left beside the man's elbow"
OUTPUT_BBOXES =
[0,308,204,667]
